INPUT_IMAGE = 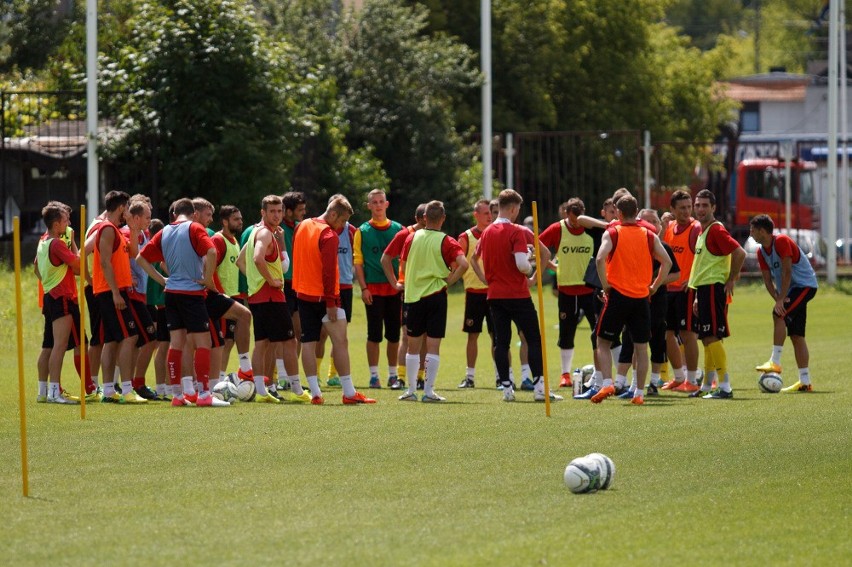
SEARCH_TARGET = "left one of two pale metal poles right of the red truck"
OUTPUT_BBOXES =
[826,2,840,285]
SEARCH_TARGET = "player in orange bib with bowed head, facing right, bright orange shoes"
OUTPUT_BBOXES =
[290,196,376,405]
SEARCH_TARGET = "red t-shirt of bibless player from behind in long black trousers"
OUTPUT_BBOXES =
[475,222,534,299]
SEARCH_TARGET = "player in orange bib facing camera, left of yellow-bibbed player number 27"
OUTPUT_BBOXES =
[662,189,701,392]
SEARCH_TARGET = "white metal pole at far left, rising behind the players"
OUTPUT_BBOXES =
[86,0,100,224]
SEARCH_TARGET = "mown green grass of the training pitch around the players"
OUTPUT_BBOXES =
[0,273,852,565]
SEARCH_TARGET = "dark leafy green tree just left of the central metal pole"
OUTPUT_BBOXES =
[336,0,481,232]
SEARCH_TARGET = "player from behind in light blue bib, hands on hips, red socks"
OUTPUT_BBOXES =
[136,198,230,407]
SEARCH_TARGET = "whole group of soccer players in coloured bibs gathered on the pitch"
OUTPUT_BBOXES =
[35,183,817,407]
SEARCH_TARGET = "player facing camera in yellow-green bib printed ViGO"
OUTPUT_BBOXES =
[539,197,595,388]
